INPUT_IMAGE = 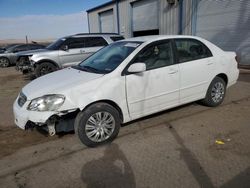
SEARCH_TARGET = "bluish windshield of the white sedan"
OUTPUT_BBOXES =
[73,41,141,74]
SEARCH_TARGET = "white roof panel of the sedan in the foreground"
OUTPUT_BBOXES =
[123,35,203,42]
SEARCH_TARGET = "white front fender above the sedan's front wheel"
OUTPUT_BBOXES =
[59,75,130,123]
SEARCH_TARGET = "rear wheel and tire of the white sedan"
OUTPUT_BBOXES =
[201,77,226,107]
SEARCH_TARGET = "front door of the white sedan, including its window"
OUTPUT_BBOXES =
[126,40,179,119]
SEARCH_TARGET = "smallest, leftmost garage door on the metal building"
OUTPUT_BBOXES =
[99,10,114,33]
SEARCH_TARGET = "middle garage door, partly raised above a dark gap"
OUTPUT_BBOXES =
[132,0,159,36]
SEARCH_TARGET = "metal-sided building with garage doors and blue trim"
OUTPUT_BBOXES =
[87,0,250,64]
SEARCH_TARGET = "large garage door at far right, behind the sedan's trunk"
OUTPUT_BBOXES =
[196,0,250,64]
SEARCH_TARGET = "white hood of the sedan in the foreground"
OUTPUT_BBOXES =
[22,68,103,100]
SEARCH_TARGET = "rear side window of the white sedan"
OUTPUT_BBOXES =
[175,39,212,63]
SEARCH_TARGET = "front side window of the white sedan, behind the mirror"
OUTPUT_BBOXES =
[134,41,174,70]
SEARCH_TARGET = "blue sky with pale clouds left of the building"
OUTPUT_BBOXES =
[0,0,109,40]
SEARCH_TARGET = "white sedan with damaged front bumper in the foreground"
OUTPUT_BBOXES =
[13,36,239,147]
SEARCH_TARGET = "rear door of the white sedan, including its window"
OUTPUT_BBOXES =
[175,39,215,104]
